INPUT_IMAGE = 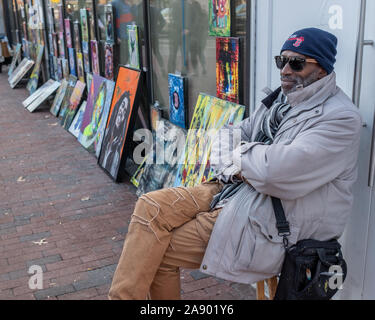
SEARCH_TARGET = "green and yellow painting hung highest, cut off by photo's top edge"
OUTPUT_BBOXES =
[208,0,231,37]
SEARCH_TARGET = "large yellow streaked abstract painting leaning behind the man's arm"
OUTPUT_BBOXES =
[174,93,245,187]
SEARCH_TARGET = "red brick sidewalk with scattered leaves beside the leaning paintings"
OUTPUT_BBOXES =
[0,67,255,300]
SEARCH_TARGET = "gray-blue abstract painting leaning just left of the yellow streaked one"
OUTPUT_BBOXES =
[133,119,186,197]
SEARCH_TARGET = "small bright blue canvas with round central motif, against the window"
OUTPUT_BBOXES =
[168,73,188,129]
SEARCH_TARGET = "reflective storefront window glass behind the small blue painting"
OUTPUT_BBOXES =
[150,0,246,122]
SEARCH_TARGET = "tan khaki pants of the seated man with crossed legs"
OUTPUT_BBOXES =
[109,182,222,300]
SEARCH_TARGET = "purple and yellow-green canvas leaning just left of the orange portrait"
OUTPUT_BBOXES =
[78,74,115,158]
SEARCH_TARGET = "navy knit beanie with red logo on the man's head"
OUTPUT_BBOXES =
[280,28,337,74]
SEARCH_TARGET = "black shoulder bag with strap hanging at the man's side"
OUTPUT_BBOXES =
[271,197,347,300]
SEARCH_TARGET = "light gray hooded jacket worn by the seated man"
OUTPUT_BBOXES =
[200,72,361,283]
